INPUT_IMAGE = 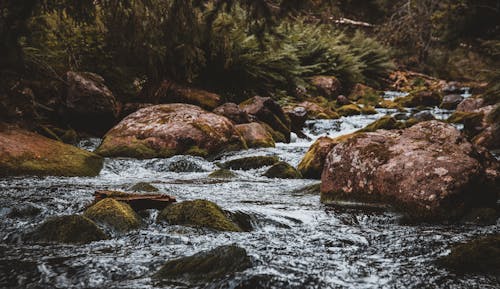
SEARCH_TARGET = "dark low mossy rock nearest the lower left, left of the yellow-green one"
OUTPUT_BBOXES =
[29,215,107,244]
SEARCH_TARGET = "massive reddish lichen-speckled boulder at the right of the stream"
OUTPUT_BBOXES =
[321,121,499,220]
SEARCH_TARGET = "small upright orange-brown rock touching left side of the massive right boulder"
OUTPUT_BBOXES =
[298,137,338,179]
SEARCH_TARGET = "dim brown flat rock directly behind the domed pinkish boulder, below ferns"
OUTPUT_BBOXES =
[154,80,221,110]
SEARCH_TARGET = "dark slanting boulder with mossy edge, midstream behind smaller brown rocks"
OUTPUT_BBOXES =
[240,96,291,142]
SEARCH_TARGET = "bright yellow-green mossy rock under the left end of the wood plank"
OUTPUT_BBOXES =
[84,198,141,233]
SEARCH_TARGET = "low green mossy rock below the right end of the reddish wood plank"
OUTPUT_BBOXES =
[157,200,242,232]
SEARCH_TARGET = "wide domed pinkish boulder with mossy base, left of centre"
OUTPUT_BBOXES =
[96,103,246,158]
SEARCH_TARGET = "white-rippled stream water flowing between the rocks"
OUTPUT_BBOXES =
[0,102,500,289]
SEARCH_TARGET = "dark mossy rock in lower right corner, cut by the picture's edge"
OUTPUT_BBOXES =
[438,235,500,276]
